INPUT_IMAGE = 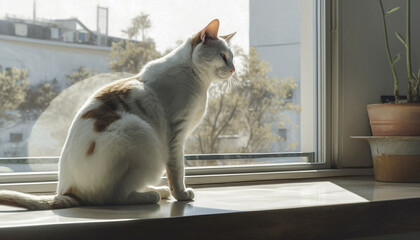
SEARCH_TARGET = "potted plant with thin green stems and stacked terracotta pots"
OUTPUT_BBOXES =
[358,0,420,182]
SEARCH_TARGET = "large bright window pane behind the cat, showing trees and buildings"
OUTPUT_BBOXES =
[0,0,326,181]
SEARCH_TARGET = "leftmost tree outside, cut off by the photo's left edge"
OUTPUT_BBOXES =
[0,68,28,124]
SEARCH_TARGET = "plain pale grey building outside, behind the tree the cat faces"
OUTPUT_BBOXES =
[249,0,301,151]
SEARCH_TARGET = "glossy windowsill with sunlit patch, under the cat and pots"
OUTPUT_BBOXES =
[0,177,420,239]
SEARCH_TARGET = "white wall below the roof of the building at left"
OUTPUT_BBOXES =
[0,35,110,85]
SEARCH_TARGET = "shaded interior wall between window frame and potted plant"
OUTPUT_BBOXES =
[333,0,420,167]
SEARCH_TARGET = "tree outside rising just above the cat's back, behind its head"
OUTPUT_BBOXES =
[109,13,161,74]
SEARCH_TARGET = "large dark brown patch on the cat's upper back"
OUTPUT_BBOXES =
[82,78,136,132]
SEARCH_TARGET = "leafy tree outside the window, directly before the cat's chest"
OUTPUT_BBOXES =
[186,48,300,157]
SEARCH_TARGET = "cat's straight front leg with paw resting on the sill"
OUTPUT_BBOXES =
[166,146,195,201]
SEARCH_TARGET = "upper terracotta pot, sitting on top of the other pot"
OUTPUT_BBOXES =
[367,103,420,136]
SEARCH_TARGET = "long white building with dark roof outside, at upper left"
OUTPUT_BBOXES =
[0,19,115,87]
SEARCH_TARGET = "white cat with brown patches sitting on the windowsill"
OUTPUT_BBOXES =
[0,19,235,210]
